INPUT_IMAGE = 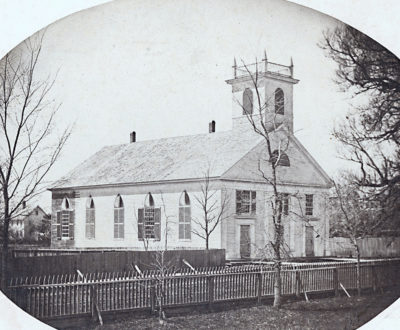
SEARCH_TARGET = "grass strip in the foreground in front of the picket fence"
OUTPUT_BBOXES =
[86,288,400,330]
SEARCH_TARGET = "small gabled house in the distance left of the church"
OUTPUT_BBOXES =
[10,205,51,242]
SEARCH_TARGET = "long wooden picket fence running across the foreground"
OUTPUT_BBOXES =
[8,260,400,320]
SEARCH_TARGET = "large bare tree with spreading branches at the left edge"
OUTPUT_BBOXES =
[0,34,71,290]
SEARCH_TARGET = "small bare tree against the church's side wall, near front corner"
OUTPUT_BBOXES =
[192,167,229,250]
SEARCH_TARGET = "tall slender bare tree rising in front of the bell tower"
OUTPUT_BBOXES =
[235,56,290,308]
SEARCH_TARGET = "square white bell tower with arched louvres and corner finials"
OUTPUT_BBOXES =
[226,52,299,133]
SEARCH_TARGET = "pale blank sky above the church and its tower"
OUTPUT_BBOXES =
[3,0,398,213]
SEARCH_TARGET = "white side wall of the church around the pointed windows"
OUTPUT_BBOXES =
[75,192,221,249]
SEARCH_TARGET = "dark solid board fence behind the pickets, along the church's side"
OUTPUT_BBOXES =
[2,249,225,277]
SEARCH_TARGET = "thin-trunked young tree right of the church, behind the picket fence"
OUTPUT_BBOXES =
[330,175,385,295]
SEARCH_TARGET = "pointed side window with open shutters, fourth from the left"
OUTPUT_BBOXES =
[138,193,161,241]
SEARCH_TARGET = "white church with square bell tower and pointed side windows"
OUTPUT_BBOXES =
[50,54,331,259]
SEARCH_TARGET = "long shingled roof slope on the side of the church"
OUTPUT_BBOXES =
[50,130,262,190]
